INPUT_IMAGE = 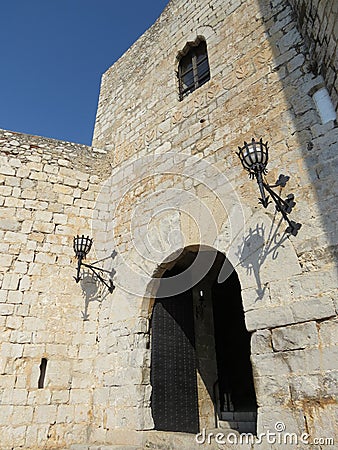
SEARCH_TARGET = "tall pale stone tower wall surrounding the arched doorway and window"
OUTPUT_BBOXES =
[93,0,338,444]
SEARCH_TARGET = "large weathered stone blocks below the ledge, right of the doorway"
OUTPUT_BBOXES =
[252,320,337,442]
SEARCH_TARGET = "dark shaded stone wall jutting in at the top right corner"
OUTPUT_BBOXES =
[290,0,338,108]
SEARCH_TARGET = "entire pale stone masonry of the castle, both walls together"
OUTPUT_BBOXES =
[0,0,338,450]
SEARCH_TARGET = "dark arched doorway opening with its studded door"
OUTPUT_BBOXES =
[151,249,257,433]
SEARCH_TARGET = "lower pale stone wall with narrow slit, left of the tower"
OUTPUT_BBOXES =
[0,131,113,450]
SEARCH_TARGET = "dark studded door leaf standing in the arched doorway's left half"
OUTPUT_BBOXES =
[151,291,199,433]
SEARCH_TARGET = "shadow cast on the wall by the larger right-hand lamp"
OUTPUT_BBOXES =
[236,218,289,301]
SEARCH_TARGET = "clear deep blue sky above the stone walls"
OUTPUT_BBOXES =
[0,0,168,145]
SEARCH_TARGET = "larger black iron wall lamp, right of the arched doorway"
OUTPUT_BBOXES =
[237,138,302,236]
